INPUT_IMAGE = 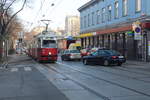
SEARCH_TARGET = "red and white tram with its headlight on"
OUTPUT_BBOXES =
[28,34,58,62]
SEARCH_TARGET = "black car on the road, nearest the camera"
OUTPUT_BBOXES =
[83,49,126,66]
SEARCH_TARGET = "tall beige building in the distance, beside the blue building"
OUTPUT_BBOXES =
[65,16,80,36]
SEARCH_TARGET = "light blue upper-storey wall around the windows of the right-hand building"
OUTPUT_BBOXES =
[80,0,150,33]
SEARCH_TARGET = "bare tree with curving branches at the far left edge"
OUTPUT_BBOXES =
[0,0,27,61]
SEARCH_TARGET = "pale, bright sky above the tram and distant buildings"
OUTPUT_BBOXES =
[13,0,90,30]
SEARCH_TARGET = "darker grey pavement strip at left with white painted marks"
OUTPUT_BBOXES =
[0,55,68,100]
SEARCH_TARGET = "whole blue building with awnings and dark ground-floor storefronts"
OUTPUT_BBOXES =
[78,0,150,61]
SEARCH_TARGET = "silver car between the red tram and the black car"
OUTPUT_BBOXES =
[61,50,81,60]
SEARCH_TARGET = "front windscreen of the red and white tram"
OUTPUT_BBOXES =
[42,40,56,48]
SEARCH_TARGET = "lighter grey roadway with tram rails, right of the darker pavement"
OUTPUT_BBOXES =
[37,56,150,100]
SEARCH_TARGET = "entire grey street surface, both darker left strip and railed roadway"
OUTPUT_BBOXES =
[0,56,150,100]
